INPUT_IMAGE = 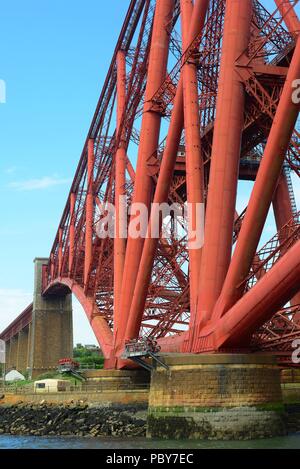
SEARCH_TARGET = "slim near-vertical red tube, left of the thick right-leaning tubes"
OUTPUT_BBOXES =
[114,51,127,333]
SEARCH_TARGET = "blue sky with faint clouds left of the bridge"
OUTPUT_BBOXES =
[0,0,298,343]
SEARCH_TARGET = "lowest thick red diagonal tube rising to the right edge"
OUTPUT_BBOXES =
[213,241,300,349]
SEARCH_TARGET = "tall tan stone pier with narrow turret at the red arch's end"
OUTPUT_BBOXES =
[29,259,73,378]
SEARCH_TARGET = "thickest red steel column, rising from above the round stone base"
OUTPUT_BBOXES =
[191,0,252,344]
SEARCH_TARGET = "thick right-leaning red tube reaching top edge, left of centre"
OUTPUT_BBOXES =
[116,0,174,345]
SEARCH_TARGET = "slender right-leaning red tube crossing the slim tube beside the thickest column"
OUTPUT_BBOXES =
[125,0,209,339]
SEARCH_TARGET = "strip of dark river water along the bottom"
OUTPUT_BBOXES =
[0,432,300,449]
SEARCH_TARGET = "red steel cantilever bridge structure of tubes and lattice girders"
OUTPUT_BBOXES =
[2,0,300,368]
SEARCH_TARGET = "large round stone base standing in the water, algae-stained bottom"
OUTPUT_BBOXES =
[147,354,286,440]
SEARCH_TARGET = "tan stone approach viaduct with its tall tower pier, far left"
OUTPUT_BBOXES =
[0,258,73,378]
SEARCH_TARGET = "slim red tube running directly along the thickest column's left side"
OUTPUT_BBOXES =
[180,0,204,314]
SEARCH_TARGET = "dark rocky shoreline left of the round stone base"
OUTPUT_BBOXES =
[0,402,147,438]
